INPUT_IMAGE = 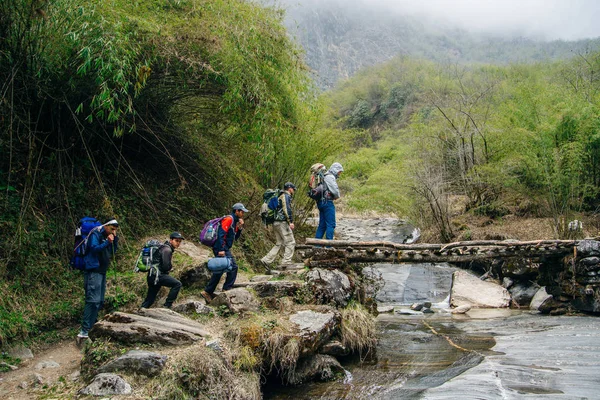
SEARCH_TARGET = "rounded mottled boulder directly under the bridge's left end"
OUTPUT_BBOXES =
[306,268,352,307]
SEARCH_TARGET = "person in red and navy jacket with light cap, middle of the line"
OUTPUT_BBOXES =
[201,203,248,302]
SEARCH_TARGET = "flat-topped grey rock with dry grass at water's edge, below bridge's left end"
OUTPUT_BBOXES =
[290,310,341,355]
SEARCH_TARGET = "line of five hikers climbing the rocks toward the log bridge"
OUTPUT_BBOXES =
[77,162,344,340]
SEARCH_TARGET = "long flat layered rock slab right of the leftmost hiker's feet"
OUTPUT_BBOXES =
[90,309,208,345]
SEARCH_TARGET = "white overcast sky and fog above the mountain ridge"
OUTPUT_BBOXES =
[283,0,600,40]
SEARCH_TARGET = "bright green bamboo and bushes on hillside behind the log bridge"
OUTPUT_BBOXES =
[326,52,600,241]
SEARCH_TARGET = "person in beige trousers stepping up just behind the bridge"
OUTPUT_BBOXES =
[260,182,296,271]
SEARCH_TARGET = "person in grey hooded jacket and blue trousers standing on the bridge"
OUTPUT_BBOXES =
[315,162,344,240]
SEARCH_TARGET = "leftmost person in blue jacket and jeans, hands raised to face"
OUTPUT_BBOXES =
[77,219,119,340]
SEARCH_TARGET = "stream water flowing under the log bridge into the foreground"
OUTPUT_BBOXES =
[265,220,600,399]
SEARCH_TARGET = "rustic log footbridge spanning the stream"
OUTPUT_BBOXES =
[298,238,598,267]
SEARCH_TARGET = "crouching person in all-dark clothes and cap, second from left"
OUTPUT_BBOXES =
[142,232,184,308]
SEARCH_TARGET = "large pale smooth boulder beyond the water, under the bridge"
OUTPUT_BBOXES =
[450,271,510,308]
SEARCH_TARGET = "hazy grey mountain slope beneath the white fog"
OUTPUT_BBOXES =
[285,3,600,89]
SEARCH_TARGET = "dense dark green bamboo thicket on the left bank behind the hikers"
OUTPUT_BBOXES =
[0,0,328,343]
